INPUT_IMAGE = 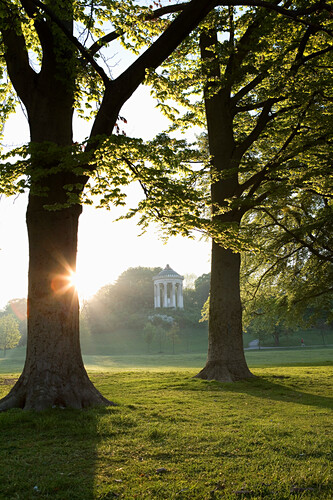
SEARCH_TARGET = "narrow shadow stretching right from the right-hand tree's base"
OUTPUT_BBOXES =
[194,375,333,409]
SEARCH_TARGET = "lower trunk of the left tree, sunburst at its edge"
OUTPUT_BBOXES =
[0,196,110,411]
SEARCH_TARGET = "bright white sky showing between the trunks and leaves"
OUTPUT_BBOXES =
[0,87,210,308]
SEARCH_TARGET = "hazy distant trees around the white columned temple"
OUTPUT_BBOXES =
[0,265,333,355]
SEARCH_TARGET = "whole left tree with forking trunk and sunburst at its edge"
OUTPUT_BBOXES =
[0,0,228,410]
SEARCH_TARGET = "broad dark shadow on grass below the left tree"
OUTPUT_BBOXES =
[0,387,122,500]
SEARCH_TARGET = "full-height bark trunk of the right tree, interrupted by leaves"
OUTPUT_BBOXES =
[196,27,253,382]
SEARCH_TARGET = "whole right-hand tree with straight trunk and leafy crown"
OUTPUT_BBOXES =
[130,2,333,381]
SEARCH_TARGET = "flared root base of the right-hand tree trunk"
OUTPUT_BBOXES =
[194,361,255,382]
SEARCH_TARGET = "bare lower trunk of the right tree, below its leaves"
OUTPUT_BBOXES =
[197,242,253,382]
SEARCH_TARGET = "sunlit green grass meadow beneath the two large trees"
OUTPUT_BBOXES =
[0,347,333,500]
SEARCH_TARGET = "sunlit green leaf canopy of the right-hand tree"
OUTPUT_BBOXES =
[130,3,333,245]
